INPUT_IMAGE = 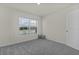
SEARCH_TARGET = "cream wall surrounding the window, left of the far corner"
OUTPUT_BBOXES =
[0,6,41,46]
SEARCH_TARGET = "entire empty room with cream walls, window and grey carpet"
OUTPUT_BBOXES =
[0,3,79,55]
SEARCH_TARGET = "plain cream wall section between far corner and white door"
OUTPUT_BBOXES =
[43,11,66,43]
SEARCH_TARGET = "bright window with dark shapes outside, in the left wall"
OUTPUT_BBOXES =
[19,17,37,34]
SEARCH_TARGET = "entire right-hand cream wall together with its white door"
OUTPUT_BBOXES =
[43,5,79,50]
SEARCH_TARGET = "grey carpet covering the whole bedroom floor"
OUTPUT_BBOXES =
[0,39,79,55]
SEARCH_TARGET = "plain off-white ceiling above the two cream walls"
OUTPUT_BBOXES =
[1,3,74,16]
